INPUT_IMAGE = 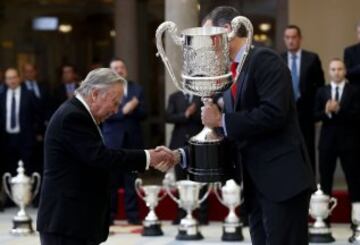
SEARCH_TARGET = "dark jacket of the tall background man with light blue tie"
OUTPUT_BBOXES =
[281,50,325,129]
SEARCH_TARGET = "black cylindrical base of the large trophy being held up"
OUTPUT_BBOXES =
[188,138,232,183]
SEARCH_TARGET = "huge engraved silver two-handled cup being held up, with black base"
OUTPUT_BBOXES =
[155,16,253,182]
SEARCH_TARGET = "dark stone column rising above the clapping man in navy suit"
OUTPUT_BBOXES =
[114,0,139,81]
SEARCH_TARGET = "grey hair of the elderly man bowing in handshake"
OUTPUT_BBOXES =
[75,68,127,97]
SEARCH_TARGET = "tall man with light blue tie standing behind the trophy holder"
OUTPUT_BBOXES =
[281,25,325,173]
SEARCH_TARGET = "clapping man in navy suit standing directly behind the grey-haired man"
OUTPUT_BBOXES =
[102,58,146,225]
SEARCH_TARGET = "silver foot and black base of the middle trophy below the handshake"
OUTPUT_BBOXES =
[176,218,204,241]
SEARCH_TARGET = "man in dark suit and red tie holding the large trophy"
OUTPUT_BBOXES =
[158,7,315,245]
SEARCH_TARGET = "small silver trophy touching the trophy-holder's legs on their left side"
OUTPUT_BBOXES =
[214,179,244,241]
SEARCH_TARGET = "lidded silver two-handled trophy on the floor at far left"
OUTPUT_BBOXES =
[3,160,40,235]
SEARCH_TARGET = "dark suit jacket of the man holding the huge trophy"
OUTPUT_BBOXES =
[224,48,314,201]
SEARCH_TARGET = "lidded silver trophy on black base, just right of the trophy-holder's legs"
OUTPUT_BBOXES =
[309,184,337,243]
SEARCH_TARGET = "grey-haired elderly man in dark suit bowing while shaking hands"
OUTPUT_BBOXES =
[37,68,175,245]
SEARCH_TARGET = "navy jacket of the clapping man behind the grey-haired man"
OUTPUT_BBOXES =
[102,81,146,149]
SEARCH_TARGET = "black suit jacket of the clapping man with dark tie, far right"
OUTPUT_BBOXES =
[315,84,360,150]
